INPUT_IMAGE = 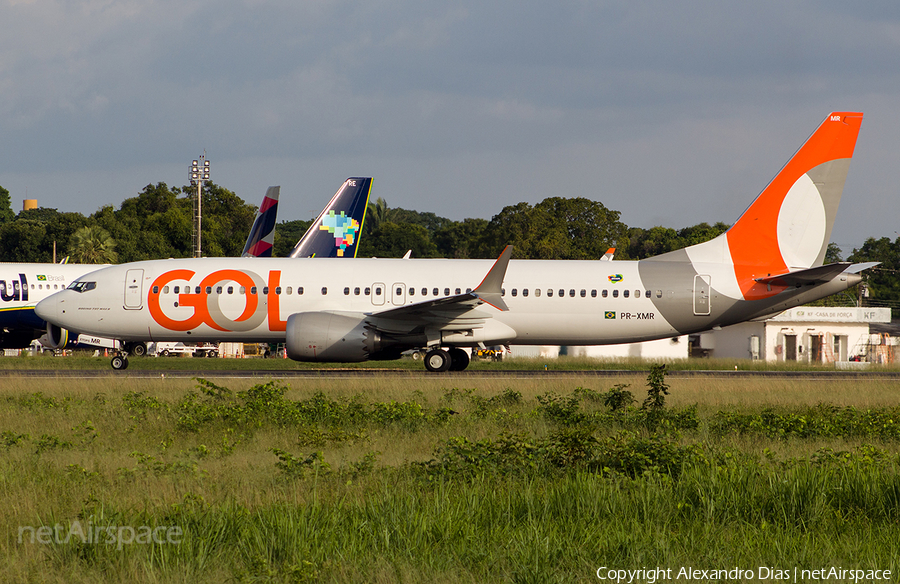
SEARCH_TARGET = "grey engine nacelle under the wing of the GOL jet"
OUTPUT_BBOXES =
[285,312,384,363]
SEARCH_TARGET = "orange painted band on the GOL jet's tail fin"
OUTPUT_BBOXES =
[726,112,862,300]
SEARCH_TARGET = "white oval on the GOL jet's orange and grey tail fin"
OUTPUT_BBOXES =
[778,174,827,269]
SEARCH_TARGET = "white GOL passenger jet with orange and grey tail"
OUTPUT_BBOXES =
[37,112,875,371]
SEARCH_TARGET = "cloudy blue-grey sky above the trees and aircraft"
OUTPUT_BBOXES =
[0,0,900,251]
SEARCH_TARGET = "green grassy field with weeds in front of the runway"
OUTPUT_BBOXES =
[0,372,900,582]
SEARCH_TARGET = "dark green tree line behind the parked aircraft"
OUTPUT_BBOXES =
[0,183,900,308]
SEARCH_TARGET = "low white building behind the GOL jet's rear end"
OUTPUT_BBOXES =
[694,306,891,363]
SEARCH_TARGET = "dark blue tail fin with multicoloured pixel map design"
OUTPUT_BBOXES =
[290,177,372,258]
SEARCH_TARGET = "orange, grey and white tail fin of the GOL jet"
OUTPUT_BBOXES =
[686,112,863,300]
